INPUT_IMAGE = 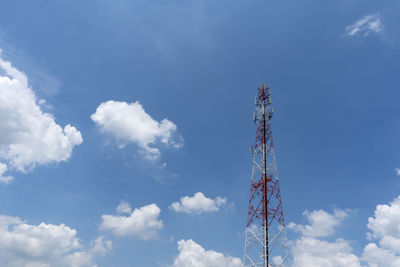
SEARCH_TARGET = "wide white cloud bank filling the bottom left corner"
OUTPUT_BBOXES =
[0,215,111,267]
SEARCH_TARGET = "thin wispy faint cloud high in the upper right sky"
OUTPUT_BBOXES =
[345,13,383,36]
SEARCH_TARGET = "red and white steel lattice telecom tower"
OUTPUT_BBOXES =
[243,84,288,267]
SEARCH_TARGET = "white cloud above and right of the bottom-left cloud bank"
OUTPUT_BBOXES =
[100,204,164,240]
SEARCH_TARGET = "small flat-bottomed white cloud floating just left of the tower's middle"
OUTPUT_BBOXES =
[170,192,227,214]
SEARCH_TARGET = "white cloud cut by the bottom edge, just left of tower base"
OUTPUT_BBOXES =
[173,239,244,267]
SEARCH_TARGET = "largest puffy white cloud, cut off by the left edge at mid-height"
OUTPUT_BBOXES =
[0,51,82,183]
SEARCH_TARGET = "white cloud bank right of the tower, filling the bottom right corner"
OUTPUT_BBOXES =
[288,196,400,267]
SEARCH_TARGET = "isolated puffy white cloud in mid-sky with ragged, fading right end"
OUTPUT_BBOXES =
[91,100,183,159]
